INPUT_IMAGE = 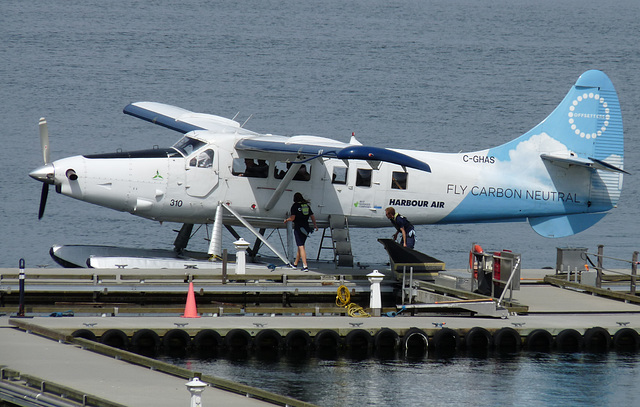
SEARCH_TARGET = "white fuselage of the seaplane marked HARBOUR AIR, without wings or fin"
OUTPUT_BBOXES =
[53,135,589,228]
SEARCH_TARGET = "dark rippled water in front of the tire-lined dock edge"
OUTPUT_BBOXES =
[165,353,640,407]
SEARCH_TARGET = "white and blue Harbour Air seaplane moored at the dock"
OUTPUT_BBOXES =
[29,70,627,267]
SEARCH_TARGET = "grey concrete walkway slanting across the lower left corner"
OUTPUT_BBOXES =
[0,316,302,407]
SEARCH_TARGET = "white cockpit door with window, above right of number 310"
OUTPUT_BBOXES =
[185,148,219,197]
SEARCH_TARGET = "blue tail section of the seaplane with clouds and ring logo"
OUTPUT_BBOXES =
[442,70,625,237]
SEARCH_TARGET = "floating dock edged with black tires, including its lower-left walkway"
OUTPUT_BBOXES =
[0,267,640,406]
